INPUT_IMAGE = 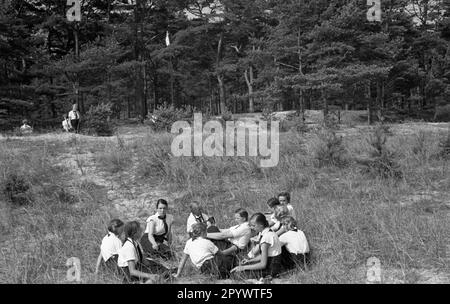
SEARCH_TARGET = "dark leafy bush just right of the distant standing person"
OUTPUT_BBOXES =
[83,103,114,136]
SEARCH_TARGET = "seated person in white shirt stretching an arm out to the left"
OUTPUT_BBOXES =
[207,208,252,255]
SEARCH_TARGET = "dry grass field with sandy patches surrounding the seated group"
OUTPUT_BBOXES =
[0,119,450,283]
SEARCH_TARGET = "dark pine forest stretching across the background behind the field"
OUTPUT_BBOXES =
[0,0,450,129]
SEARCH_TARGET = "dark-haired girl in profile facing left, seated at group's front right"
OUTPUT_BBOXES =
[231,213,281,279]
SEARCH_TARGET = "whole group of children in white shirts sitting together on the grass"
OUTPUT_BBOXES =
[96,192,310,282]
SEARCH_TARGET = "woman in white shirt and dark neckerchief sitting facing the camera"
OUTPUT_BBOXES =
[141,199,174,260]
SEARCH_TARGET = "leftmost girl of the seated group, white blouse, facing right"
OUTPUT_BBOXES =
[95,219,124,275]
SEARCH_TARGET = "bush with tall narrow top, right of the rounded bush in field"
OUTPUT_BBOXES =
[359,125,402,178]
